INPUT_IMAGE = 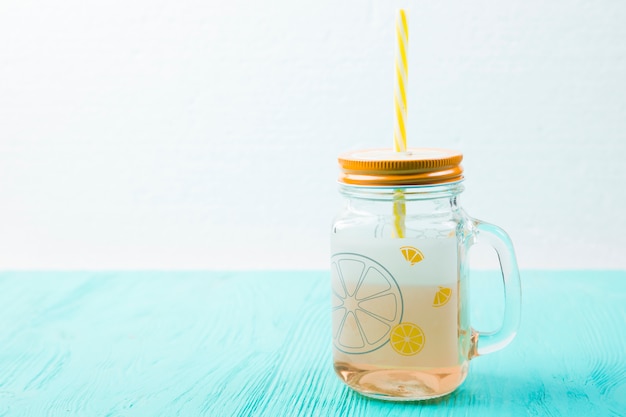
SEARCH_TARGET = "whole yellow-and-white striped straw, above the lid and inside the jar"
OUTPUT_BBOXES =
[393,9,409,238]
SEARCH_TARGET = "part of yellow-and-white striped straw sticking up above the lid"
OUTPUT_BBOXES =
[393,9,409,152]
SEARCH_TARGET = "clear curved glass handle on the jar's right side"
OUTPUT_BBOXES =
[470,220,522,356]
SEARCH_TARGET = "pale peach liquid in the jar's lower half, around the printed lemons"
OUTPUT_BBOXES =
[333,283,470,401]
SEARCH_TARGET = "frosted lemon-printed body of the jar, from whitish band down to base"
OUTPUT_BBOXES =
[331,230,469,399]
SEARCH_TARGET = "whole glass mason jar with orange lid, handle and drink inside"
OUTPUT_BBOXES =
[331,148,521,401]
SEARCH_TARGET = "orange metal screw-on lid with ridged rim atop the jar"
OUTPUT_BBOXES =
[339,148,463,186]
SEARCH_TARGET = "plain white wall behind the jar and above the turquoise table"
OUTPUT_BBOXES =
[0,0,626,270]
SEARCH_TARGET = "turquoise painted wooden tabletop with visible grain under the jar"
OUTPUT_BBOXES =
[0,271,626,417]
